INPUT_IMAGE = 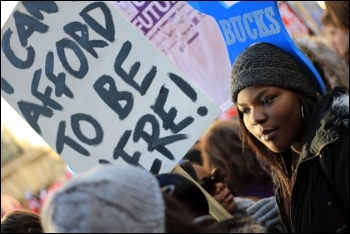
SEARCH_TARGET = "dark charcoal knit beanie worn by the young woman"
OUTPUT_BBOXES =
[231,42,317,103]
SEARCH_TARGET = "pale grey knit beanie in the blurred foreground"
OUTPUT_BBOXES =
[41,164,165,233]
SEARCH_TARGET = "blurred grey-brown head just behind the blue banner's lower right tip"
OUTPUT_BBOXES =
[294,36,349,91]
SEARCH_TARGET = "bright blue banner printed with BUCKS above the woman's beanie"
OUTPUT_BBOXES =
[187,1,325,95]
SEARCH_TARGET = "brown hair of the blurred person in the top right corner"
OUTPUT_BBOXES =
[325,1,349,31]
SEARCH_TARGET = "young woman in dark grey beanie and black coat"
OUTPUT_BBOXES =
[231,43,349,233]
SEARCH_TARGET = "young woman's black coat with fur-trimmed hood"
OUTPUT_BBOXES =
[275,88,349,233]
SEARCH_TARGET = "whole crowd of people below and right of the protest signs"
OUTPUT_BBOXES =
[1,1,349,233]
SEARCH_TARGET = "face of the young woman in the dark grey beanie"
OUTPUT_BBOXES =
[236,86,304,153]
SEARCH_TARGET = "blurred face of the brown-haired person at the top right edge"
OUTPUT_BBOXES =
[327,26,349,60]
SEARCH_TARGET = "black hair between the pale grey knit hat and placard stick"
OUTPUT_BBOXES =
[156,173,209,217]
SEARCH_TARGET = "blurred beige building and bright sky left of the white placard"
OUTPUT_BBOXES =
[1,1,71,216]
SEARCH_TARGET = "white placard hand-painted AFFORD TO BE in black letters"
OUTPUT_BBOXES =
[1,1,220,173]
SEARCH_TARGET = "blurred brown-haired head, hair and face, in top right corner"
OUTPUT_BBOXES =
[322,1,349,65]
